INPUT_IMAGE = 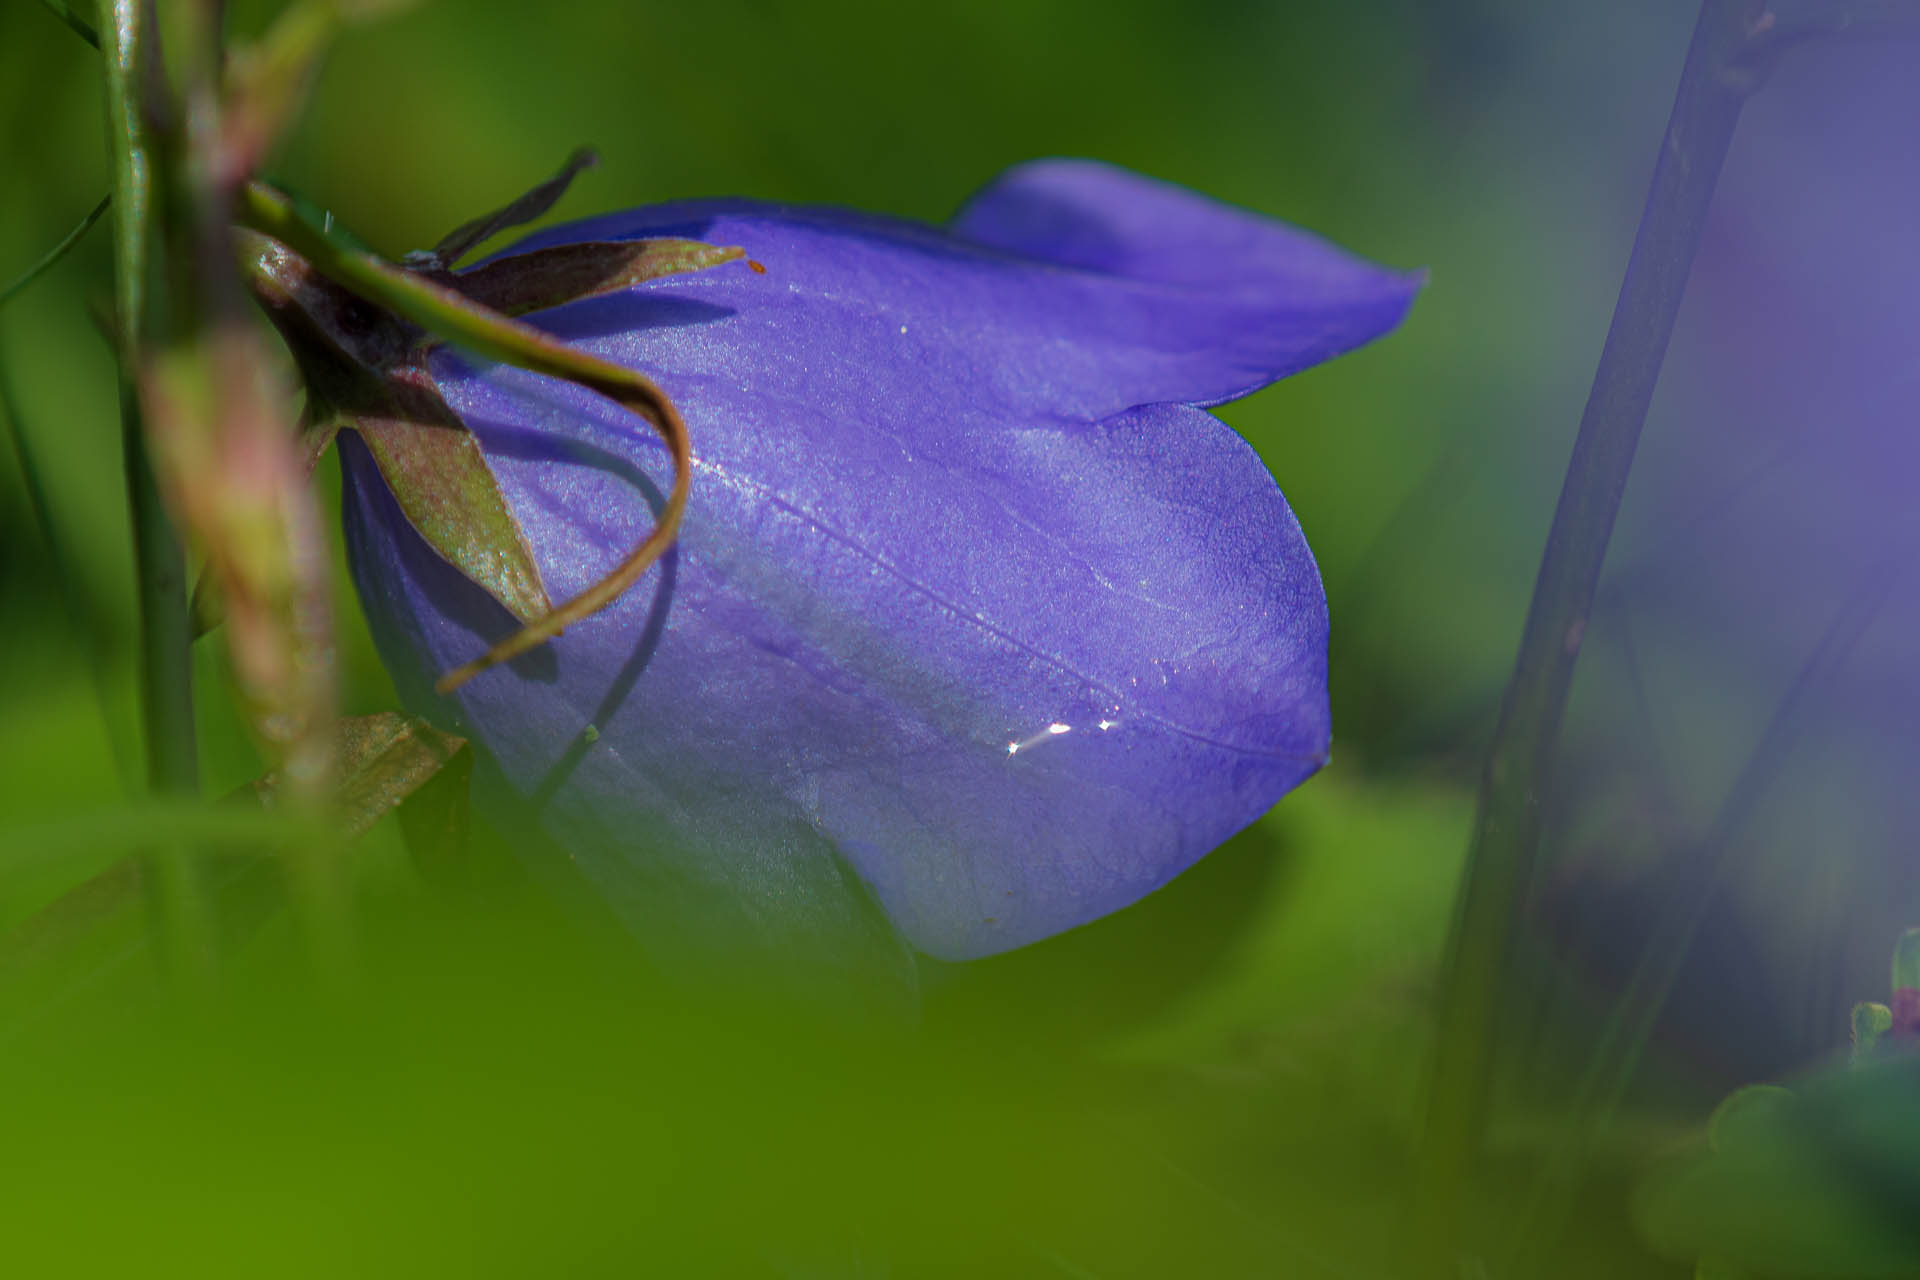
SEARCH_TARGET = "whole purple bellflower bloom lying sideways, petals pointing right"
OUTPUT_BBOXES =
[330,161,1419,960]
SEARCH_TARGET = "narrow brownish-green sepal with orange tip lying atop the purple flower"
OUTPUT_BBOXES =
[453,236,747,315]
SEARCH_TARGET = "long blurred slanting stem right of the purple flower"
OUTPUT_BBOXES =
[1413,0,1757,1274]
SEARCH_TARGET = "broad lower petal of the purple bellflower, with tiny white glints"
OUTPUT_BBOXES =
[351,376,1329,960]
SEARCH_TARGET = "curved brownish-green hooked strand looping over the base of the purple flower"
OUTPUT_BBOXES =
[238,182,693,693]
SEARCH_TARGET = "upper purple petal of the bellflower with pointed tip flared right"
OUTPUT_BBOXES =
[480,167,1421,418]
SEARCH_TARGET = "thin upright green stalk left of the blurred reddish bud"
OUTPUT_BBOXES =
[100,0,213,981]
